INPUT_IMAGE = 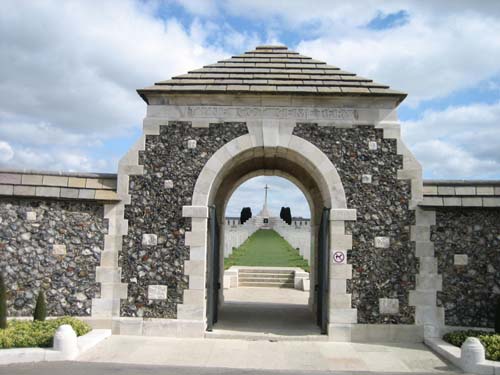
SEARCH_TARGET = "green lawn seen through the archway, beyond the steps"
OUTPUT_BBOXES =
[224,229,309,272]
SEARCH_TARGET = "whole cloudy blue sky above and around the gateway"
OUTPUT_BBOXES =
[0,0,500,217]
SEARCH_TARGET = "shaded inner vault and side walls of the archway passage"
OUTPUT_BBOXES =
[199,143,336,335]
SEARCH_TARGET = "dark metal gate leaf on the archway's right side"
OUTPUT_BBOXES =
[315,208,330,334]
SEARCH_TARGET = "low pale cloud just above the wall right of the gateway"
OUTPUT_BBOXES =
[402,101,500,178]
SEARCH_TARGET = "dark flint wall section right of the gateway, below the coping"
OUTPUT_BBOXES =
[431,208,500,328]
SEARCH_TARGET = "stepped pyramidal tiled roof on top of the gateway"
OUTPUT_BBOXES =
[137,46,406,101]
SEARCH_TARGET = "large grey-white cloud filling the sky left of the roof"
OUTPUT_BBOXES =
[0,0,230,171]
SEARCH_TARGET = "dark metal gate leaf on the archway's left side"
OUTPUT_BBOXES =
[207,206,220,331]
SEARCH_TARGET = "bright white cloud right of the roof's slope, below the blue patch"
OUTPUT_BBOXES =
[297,9,500,106]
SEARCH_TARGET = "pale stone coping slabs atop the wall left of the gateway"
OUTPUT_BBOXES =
[0,170,119,201]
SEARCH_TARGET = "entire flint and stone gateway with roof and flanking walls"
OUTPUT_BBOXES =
[0,46,500,341]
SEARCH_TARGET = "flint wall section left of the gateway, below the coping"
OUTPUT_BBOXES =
[0,198,107,316]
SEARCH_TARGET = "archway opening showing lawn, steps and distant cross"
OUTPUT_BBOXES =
[214,173,314,336]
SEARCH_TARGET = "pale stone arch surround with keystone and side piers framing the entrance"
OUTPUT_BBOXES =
[182,127,357,335]
